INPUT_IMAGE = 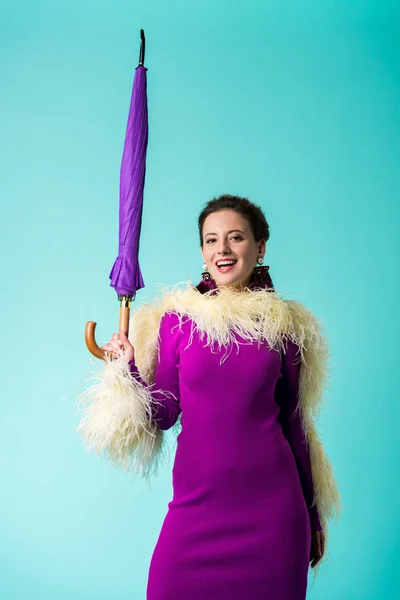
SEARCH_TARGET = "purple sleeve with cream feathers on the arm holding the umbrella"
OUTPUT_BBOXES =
[78,305,181,481]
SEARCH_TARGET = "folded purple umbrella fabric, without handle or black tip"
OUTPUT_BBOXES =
[109,65,148,298]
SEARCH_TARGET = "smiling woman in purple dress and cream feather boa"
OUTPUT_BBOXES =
[81,195,339,600]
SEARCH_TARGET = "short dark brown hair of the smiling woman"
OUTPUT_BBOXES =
[198,194,269,247]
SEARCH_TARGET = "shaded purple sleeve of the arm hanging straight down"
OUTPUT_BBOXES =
[275,341,322,531]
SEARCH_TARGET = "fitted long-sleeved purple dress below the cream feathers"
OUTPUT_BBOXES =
[130,312,321,600]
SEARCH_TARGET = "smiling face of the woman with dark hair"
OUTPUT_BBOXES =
[201,209,265,289]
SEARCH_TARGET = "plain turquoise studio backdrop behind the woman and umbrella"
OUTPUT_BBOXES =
[0,0,400,600]
